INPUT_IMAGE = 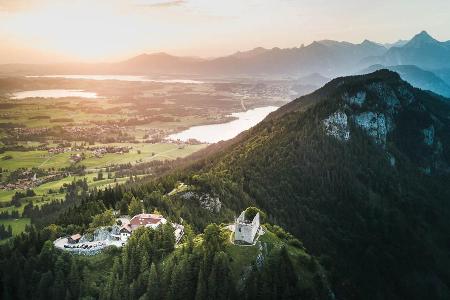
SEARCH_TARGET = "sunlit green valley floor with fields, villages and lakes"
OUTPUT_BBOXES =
[0,75,302,241]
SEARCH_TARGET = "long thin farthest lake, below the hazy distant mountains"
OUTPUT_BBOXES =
[26,75,205,84]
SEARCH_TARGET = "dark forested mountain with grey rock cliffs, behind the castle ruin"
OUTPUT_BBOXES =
[182,70,450,299]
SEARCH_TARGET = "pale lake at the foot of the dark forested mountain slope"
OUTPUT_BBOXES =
[168,106,278,143]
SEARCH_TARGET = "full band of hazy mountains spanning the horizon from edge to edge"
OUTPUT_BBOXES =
[0,31,450,96]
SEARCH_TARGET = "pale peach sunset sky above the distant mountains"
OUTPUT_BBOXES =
[0,0,450,63]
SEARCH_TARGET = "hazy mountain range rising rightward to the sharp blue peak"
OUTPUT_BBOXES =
[110,31,450,78]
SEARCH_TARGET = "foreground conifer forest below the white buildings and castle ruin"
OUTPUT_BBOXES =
[0,219,329,300]
